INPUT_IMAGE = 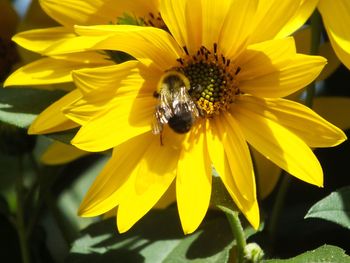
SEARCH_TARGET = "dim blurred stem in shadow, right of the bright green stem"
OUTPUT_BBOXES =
[267,171,291,245]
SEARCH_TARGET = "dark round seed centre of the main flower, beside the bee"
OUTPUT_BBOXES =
[177,44,240,117]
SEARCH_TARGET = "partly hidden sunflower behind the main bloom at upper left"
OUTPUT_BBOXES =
[4,0,163,134]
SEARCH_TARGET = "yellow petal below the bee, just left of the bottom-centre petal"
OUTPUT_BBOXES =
[117,136,179,233]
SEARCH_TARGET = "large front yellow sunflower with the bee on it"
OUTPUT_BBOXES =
[34,0,346,233]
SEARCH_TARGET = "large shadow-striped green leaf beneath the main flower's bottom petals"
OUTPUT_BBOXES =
[67,210,239,263]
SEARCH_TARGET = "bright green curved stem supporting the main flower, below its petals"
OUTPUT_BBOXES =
[220,206,247,263]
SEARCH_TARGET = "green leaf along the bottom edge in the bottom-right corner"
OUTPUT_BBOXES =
[263,245,350,263]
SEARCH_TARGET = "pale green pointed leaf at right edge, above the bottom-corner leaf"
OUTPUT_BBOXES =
[305,186,350,229]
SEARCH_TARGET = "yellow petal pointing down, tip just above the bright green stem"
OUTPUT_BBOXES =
[206,117,259,228]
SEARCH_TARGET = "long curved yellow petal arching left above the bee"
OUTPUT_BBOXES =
[46,25,182,71]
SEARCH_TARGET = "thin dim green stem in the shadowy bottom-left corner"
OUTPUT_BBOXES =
[16,156,30,263]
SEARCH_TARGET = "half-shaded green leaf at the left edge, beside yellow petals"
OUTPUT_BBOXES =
[0,88,64,128]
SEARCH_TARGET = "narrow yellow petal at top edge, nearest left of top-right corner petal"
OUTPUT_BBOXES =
[277,0,319,38]
